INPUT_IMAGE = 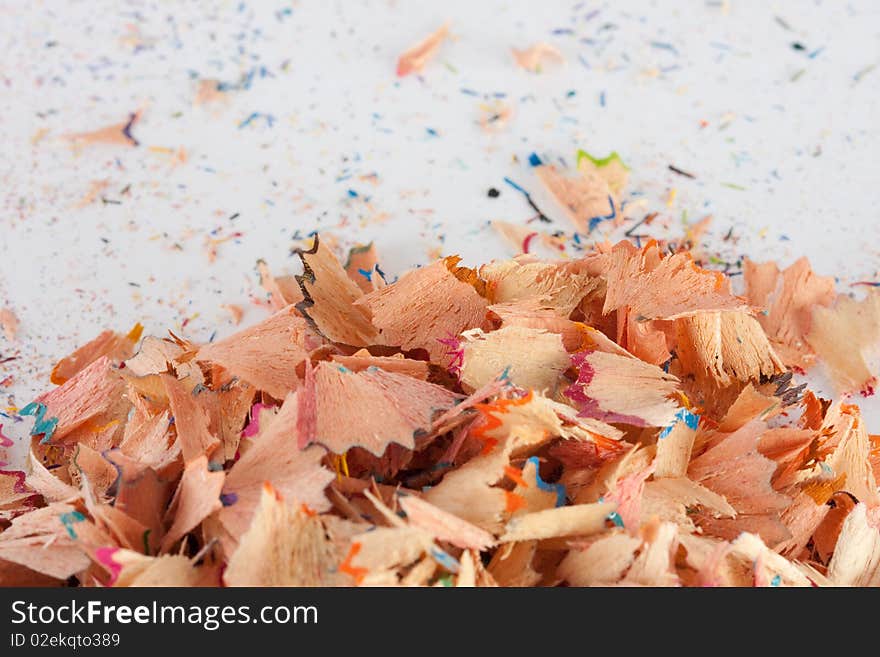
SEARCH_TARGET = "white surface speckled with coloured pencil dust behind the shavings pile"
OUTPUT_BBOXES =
[0,0,880,464]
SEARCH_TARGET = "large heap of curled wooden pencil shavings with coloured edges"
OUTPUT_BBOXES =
[0,229,880,586]
